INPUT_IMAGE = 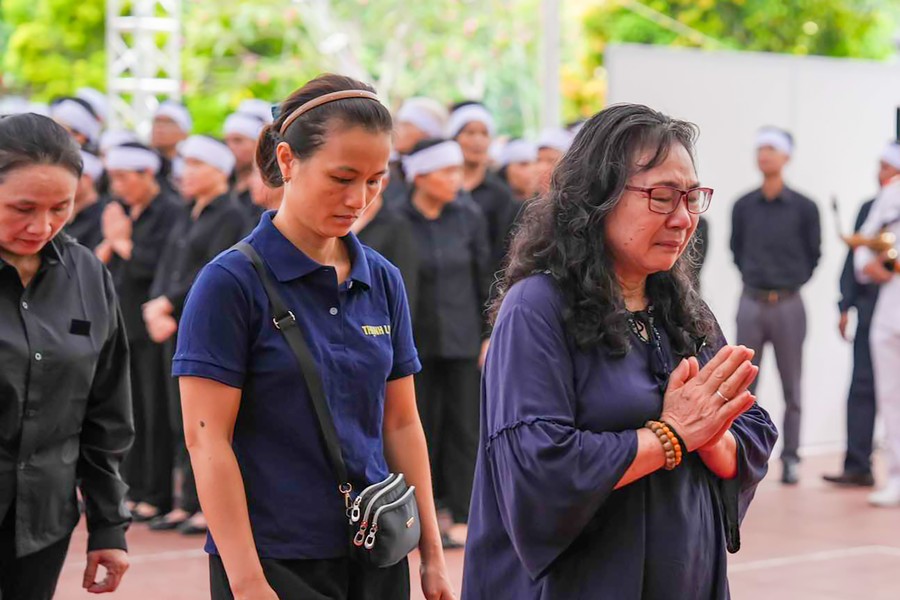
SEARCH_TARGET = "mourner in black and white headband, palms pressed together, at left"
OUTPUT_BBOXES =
[96,143,183,522]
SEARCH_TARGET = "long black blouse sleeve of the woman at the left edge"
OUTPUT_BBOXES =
[76,270,134,551]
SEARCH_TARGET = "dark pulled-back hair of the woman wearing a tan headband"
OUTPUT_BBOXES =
[256,73,393,188]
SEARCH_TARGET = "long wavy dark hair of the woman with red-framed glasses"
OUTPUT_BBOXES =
[492,104,717,356]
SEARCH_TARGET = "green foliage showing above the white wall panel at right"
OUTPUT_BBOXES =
[564,0,900,114]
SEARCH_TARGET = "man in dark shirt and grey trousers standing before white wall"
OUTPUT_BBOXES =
[731,128,821,484]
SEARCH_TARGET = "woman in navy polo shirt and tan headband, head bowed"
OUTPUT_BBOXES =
[173,75,453,600]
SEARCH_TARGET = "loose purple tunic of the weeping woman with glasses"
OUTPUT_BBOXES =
[463,275,778,600]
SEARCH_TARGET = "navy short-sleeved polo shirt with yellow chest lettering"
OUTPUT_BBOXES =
[172,213,421,559]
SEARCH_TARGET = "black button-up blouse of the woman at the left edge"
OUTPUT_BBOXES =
[0,234,134,556]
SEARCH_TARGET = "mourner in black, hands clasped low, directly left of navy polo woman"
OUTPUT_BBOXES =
[143,135,247,534]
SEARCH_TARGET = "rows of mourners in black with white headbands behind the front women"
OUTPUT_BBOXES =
[0,90,577,547]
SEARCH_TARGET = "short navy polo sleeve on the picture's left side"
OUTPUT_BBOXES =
[172,263,255,388]
